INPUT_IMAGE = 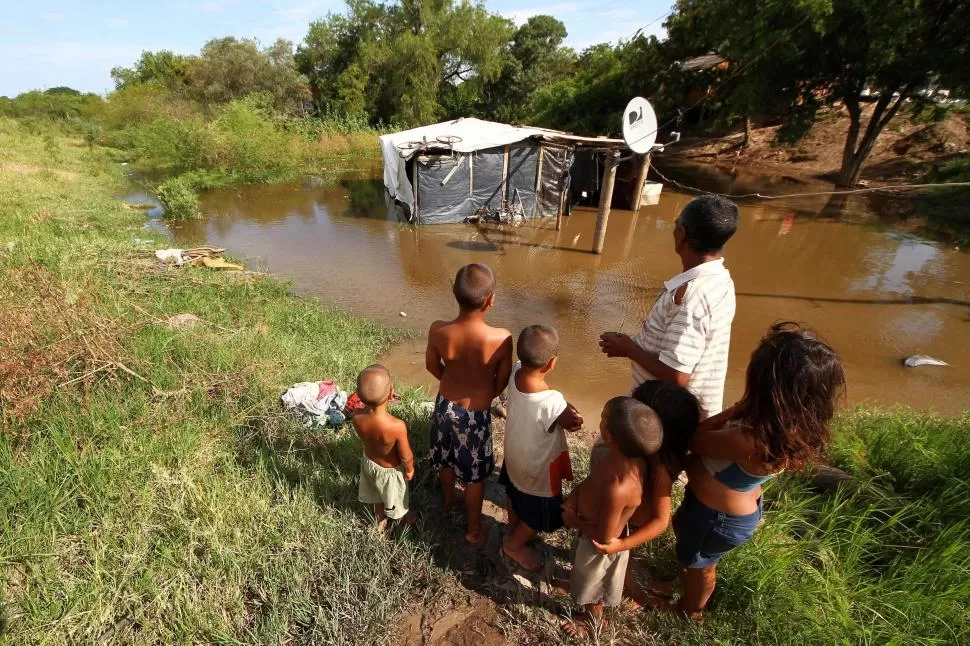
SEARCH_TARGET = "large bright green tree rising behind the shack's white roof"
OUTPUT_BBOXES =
[297,0,511,125]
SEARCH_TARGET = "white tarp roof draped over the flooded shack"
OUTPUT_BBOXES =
[377,117,549,208]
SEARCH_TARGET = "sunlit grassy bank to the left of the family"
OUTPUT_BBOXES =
[0,121,436,644]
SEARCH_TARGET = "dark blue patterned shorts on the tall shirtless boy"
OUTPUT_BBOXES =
[430,394,495,484]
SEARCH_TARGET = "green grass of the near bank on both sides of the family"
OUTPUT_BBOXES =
[0,120,970,644]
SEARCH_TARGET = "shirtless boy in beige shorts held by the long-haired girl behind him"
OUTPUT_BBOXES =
[564,397,663,633]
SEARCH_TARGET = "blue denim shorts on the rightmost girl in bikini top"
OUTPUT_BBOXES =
[673,487,761,568]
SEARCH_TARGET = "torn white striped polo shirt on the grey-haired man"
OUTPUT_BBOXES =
[631,258,735,417]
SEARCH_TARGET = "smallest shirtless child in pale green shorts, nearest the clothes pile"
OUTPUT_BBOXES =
[350,365,414,530]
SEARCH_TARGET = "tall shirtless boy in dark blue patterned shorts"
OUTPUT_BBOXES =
[425,264,512,543]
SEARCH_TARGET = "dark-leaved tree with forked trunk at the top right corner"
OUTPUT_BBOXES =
[667,0,970,186]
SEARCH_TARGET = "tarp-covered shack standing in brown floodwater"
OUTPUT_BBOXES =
[379,118,650,253]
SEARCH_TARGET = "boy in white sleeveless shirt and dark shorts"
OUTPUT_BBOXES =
[499,325,583,572]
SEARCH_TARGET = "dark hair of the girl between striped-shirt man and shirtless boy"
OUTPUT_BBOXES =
[633,379,701,477]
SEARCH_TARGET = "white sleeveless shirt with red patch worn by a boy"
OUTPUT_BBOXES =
[504,362,572,498]
